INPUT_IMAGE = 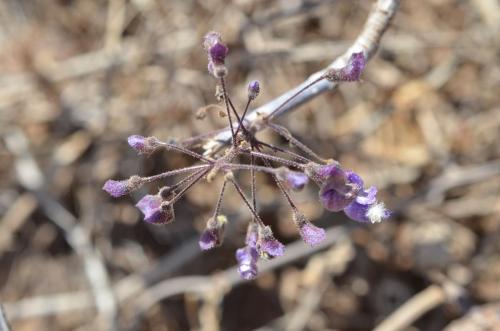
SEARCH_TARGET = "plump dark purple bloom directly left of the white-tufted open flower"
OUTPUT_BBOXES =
[319,167,363,211]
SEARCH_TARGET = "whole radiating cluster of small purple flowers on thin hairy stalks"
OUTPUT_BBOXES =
[103,32,389,279]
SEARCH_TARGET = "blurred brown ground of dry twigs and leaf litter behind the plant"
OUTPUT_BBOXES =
[0,0,500,331]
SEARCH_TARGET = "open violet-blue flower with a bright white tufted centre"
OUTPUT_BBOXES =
[344,186,391,223]
